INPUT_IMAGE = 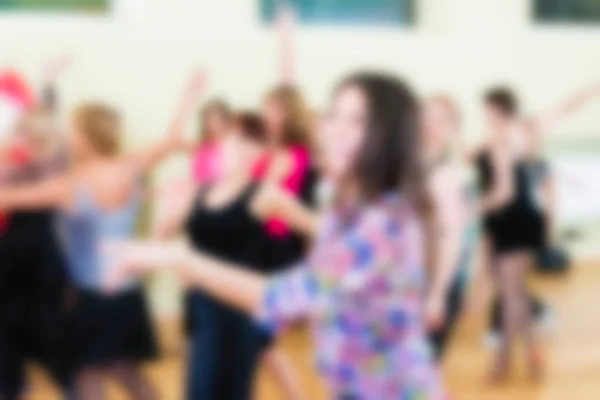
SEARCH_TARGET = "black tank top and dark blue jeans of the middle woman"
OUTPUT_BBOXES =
[186,184,266,399]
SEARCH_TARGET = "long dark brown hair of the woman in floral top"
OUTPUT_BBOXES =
[338,72,436,276]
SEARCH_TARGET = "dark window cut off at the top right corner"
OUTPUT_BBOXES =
[532,0,600,23]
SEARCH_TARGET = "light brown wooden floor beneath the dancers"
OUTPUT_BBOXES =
[30,262,600,400]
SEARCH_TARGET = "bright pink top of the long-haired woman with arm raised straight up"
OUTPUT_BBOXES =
[254,146,310,238]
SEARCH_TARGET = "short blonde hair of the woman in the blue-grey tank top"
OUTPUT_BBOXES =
[74,104,121,156]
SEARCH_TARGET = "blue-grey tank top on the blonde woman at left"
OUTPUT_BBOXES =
[61,181,141,290]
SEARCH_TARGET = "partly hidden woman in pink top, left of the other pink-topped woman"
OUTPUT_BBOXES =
[192,100,231,185]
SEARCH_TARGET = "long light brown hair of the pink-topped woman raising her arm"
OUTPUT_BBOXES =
[266,85,312,146]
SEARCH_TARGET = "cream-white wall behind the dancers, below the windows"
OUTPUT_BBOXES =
[0,0,600,316]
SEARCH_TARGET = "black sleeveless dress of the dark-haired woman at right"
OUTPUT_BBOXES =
[477,151,544,253]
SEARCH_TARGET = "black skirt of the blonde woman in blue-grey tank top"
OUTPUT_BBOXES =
[65,288,157,371]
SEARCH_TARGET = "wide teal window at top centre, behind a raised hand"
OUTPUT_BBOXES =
[260,0,416,25]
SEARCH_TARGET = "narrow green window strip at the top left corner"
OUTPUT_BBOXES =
[0,0,111,14]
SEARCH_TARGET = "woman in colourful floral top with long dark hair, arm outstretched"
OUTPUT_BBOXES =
[107,73,445,400]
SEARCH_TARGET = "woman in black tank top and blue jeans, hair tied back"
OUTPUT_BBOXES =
[155,114,310,400]
